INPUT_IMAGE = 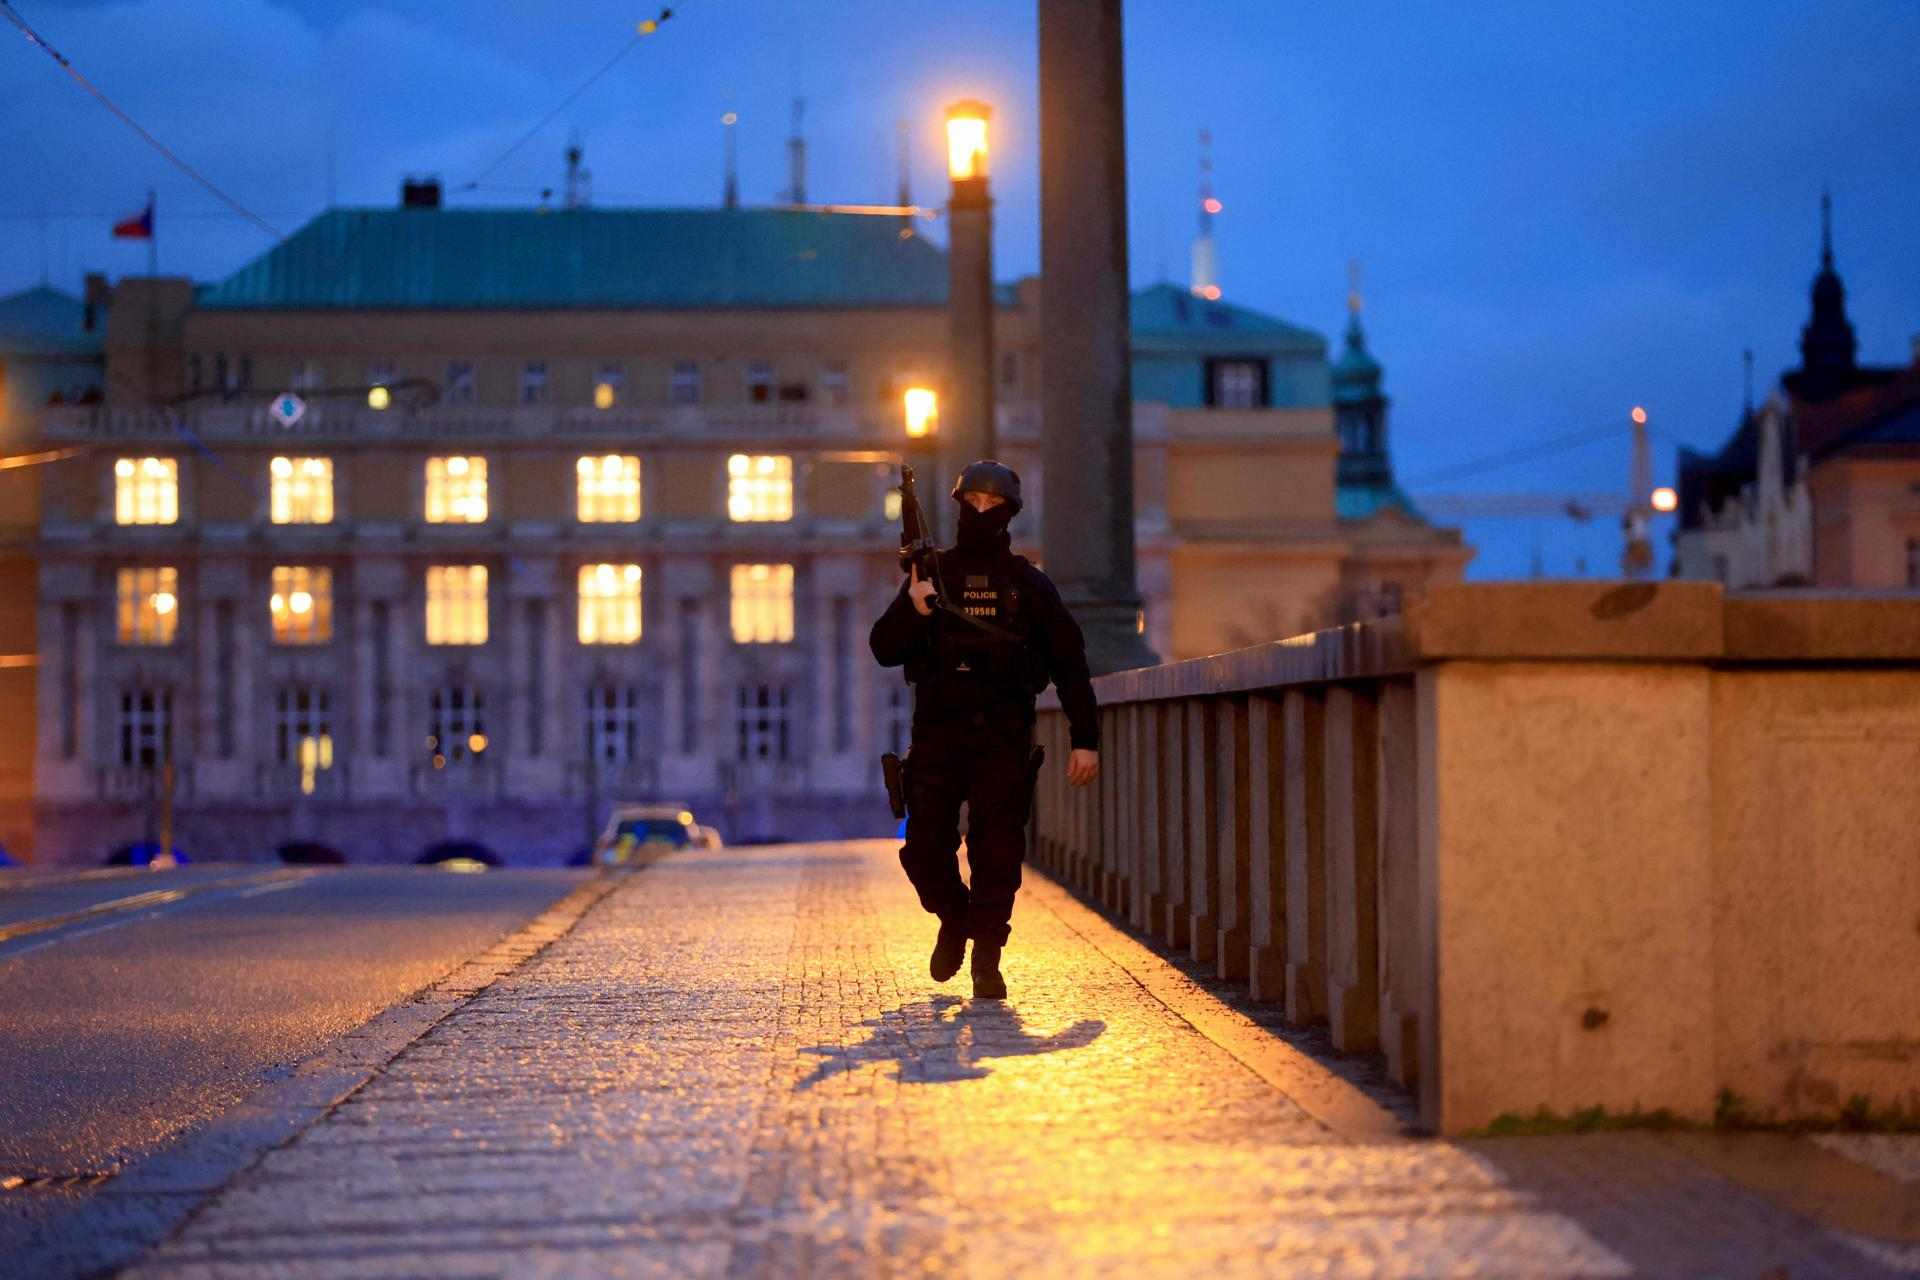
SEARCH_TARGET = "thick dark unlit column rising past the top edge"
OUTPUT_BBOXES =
[1039,0,1158,674]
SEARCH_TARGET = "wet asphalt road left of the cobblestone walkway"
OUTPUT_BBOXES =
[0,867,588,1270]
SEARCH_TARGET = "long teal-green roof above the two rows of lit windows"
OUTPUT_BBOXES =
[198,209,960,311]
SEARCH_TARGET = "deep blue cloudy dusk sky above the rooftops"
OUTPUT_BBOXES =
[0,0,1920,578]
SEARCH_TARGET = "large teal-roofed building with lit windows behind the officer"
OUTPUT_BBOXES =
[36,189,1467,862]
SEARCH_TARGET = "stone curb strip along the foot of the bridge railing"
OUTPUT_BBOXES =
[1025,865,1411,1142]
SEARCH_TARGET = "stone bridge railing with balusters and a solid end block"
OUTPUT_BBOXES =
[1033,583,1920,1132]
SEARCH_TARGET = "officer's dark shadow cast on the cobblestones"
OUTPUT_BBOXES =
[795,996,1106,1092]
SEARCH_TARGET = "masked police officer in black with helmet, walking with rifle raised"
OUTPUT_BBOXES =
[870,461,1100,1000]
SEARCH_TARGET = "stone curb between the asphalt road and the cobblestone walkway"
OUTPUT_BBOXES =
[26,864,651,1276]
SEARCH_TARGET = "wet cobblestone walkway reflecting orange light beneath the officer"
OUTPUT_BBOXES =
[131,842,1899,1280]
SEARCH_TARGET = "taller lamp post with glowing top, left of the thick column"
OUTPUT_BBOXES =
[935,100,996,510]
